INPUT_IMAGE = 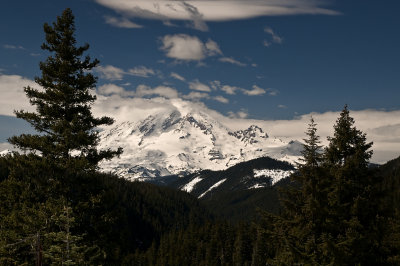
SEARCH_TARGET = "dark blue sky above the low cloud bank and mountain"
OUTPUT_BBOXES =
[0,0,400,119]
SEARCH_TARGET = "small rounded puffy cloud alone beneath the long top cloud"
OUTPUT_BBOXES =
[160,34,222,61]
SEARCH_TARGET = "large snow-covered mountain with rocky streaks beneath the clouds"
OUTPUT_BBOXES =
[100,99,301,180]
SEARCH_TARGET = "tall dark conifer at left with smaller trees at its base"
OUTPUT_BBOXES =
[0,9,122,265]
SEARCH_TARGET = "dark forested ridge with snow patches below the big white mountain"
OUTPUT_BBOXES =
[169,157,295,221]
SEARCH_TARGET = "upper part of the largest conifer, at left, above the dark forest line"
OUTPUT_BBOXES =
[9,9,122,170]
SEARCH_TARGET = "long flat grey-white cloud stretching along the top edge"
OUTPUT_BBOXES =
[96,0,339,23]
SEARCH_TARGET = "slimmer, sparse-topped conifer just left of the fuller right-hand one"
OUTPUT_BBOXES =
[276,118,329,265]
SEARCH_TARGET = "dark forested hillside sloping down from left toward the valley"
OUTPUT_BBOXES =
[0,160,212,265]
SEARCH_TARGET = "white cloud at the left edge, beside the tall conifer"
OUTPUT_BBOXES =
[0,74,40,116]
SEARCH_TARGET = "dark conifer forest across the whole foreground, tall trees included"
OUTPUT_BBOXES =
[0,9,400,266]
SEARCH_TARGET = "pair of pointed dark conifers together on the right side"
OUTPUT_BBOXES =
[271,106,398,265]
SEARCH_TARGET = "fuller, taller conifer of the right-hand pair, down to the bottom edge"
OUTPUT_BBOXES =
[324,105,381,264]
